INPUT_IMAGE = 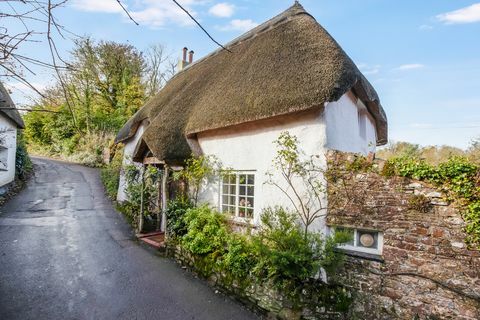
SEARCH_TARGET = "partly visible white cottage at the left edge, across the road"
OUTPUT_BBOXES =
[0,83,24,194]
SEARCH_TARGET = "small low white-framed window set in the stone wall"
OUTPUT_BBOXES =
[334,227,383,255]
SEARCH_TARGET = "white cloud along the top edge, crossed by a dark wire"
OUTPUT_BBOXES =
[72,0,207,28]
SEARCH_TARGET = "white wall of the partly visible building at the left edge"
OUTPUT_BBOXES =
[0,114,17,187]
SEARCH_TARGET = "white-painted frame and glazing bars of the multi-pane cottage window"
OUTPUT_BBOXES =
[218,170,256,221]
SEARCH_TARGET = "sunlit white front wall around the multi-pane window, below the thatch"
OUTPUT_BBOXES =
[197,111,326,231]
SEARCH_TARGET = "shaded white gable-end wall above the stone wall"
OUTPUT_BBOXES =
[325,93,377,155]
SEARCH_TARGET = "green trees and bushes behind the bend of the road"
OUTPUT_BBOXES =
[23,38,173,166]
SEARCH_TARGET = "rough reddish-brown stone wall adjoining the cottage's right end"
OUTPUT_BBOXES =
[327,153,480,320]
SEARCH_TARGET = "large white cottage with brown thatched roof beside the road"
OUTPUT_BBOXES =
[116,3,387,229]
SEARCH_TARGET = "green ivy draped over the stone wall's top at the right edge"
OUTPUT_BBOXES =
[387,157,480,248]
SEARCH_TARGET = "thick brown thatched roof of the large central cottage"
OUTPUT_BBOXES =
[116,4,387,160]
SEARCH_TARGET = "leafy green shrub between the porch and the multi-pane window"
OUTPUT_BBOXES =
[173,155,221,206]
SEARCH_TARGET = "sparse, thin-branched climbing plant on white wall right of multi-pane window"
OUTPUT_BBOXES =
[267,131,326,237]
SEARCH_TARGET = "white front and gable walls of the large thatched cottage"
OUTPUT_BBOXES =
[197,92,376,232]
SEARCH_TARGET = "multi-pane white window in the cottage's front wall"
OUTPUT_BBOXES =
[220,172,255,219]
